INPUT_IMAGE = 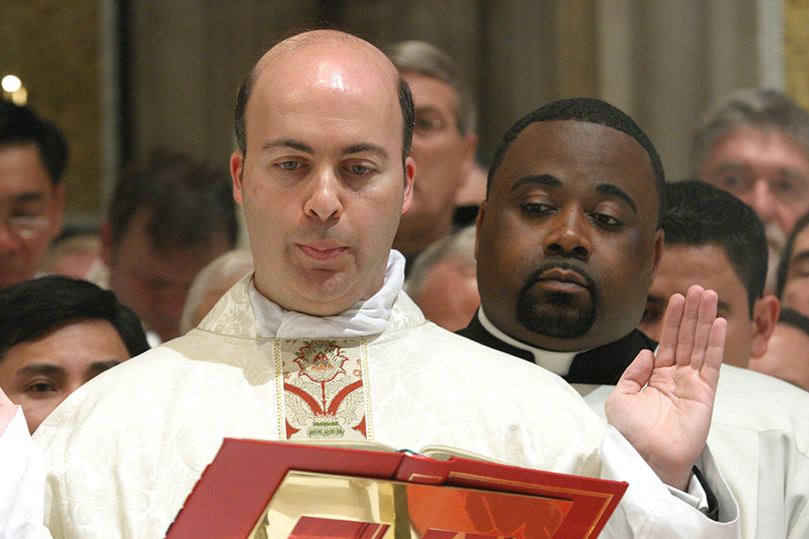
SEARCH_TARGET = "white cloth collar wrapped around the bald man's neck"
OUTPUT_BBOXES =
[249,249,405,339]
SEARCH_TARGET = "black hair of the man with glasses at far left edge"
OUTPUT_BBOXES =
[0,99,69,187]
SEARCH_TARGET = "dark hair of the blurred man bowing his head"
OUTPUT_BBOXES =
[108,150,239,252]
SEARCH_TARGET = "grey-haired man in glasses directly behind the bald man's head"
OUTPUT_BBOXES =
[386,41,478,274]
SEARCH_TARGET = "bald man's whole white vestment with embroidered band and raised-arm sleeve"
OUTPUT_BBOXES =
[23,257,738,539]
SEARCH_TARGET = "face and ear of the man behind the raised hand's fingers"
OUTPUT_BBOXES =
[638,245,778,368]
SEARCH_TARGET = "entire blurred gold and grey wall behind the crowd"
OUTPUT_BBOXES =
[0,0,809,224]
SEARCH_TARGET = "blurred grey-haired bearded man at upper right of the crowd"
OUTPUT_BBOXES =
[691,89,809,292]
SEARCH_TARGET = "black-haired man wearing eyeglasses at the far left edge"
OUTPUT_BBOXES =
[0,101,68,287]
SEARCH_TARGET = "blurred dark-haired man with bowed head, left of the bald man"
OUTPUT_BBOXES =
[101,153,238,346]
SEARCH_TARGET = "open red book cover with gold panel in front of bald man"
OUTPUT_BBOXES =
[166,438,627,539]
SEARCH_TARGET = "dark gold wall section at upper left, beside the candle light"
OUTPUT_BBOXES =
[0,0,101,219]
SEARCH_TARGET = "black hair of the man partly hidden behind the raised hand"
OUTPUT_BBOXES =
[660,180,768,320]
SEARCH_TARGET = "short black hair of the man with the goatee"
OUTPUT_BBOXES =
[486,97,666,206]
